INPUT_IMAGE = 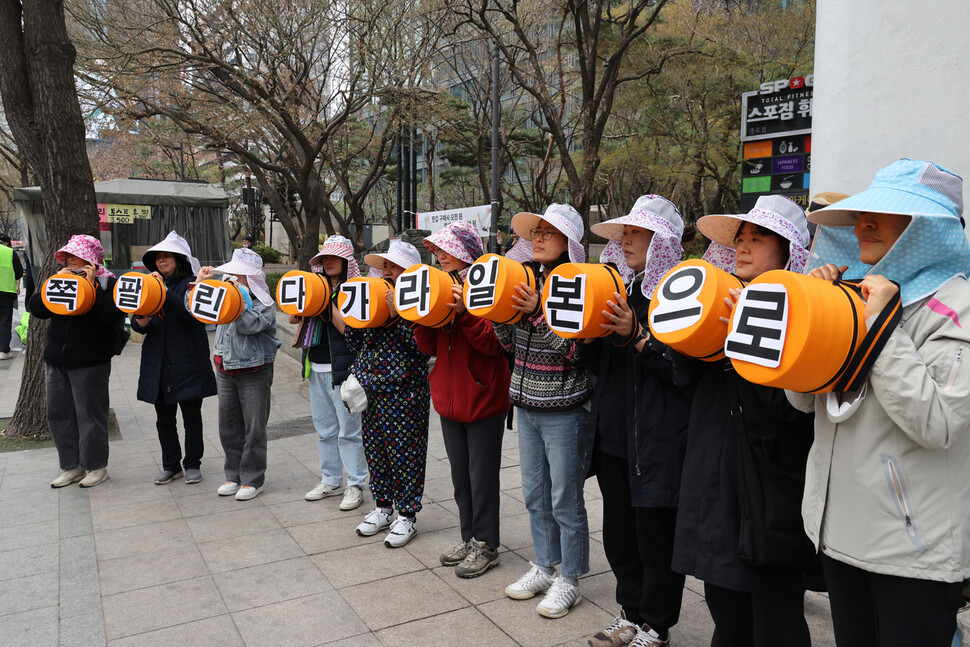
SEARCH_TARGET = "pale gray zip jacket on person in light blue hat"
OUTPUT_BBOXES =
[788,278,970,582]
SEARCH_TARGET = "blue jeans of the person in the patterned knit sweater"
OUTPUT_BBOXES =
[516,407,589,577]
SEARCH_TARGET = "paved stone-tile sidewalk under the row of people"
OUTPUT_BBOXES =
[0,312,834,647]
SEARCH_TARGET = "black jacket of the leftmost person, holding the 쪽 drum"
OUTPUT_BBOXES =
[27,277,125,368]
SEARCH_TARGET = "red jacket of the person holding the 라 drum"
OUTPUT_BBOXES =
[414,313,512,422]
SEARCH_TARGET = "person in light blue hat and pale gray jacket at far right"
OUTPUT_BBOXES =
[788,159,970,647]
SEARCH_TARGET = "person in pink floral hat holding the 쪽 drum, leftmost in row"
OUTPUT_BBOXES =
[28,234,125,488]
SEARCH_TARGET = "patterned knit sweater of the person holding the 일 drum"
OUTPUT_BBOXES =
[495,310,592,411]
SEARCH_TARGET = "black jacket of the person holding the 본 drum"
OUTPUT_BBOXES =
[580,282,690,508]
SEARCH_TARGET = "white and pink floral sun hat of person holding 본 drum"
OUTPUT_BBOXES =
[590,195,684,299]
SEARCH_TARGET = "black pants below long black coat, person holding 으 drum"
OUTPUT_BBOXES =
[704,582,812,647]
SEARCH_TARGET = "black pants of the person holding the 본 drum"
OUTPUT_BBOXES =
[593,451,684,638]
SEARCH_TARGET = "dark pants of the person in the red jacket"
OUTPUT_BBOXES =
[441,414,505,548]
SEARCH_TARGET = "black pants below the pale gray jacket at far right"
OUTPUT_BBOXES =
[822,554,963,647]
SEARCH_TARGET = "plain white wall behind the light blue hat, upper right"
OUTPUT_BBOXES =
[811,0,970,230]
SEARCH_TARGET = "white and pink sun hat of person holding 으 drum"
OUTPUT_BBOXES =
[697,195,808,274]
